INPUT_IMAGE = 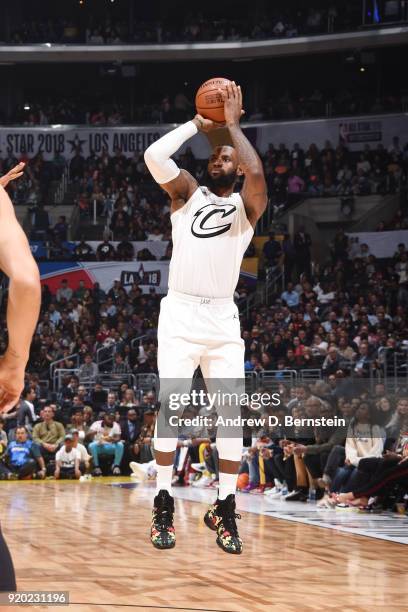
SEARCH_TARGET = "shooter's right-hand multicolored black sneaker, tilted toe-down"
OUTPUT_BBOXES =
[204,494,242,555]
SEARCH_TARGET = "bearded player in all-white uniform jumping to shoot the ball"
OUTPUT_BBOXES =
[145,82,267,554]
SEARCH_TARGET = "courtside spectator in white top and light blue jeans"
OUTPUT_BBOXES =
[89,412,124,476]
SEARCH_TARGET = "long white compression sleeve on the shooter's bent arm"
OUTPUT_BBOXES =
[144,121,198,185]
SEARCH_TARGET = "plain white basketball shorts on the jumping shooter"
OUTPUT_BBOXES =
[157,290,245,379]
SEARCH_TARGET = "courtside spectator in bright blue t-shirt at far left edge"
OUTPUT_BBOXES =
[0,426,46,480]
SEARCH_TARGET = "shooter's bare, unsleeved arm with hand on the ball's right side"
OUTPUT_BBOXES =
[220,81,268,226]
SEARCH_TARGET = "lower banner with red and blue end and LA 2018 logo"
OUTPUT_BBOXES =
[39,261,169,293]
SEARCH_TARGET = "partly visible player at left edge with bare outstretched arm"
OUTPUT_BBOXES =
[0,163,41,591]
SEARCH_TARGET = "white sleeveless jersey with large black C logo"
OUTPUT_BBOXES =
[169,187,254,298]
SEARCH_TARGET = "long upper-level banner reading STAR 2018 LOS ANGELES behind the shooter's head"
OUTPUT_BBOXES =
[0,113,408,160]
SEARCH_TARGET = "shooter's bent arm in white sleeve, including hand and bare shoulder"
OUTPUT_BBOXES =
[144,115,219,212]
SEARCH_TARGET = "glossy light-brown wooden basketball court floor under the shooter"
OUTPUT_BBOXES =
[1,478,408,612]
